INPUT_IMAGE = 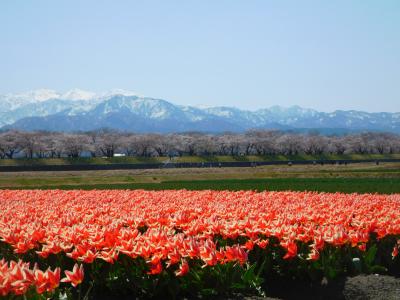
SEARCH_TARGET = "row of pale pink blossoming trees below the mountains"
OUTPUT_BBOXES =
[0,130,400,159]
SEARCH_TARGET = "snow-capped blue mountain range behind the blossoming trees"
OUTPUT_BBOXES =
[0,89,400,133]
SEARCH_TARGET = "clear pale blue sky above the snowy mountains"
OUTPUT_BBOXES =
[0,0,400,111]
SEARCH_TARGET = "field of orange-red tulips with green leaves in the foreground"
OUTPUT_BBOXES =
[0,190,400,299]
